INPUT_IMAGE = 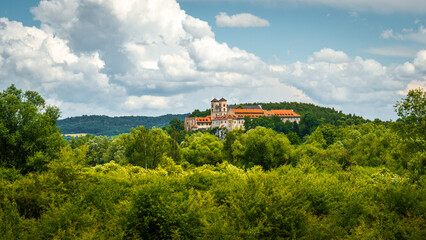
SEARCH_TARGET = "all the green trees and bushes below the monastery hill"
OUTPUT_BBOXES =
[0,86,426,239]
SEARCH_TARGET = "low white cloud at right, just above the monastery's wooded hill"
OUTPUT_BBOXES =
[270,49,426,117]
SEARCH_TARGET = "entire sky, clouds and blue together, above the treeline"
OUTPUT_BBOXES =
[0,0,426,120]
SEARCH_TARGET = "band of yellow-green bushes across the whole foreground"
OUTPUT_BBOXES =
[0,158,426,239]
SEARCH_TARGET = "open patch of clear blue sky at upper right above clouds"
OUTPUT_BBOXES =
[180,1,426,64]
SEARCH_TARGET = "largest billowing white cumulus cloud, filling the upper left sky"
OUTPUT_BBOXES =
[0,0,280,117]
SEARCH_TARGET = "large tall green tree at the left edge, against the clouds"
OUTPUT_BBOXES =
[0,85,64,173]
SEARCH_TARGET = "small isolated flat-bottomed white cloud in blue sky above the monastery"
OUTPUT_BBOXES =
[216,12,269,27]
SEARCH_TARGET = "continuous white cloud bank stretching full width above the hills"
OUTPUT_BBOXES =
[0,0,426,119]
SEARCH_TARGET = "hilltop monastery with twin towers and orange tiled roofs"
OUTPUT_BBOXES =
[185,98,300,131]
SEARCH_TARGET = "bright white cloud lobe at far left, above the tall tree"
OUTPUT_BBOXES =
[0,18,123,107]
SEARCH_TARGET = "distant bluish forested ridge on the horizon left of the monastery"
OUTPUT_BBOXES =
[56,114,189,136]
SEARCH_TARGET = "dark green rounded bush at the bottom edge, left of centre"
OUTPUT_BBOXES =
[126,179,209,239]
